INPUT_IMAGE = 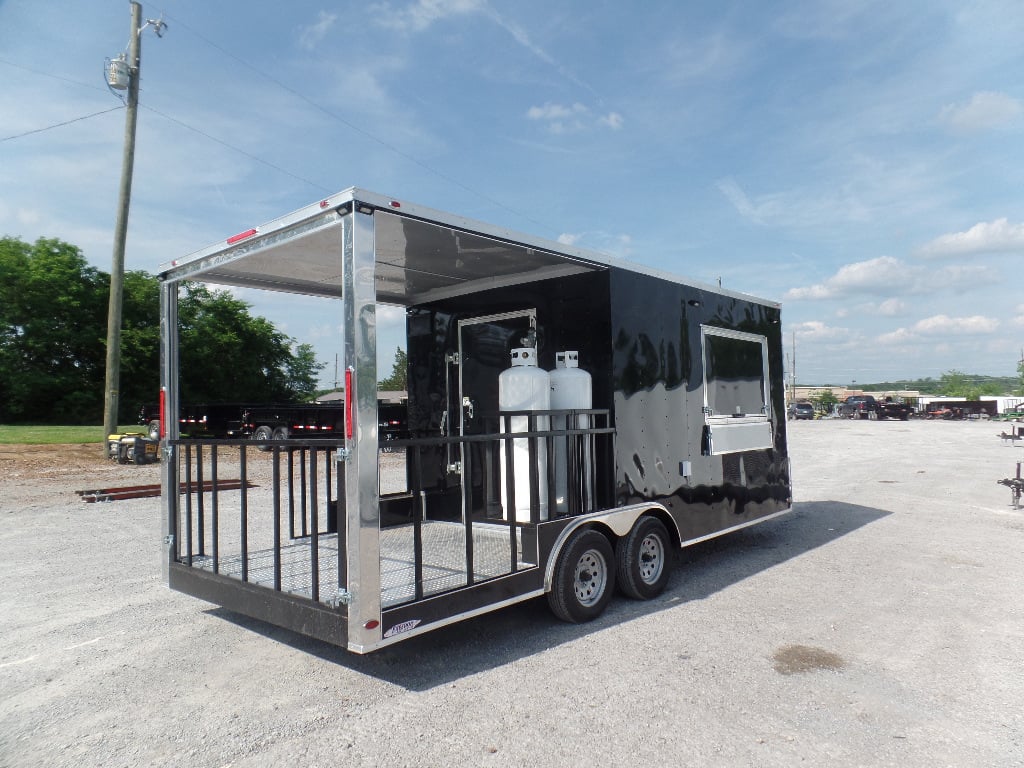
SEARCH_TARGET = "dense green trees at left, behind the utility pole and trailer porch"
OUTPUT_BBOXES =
[0,238,324,424]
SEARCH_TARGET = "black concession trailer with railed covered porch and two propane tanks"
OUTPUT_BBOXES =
[160,188,792,653]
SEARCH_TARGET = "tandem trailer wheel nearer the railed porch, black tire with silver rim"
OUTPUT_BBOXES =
[548,529,615,624]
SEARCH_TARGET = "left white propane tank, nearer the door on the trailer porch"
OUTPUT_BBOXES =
[498,347,551,522]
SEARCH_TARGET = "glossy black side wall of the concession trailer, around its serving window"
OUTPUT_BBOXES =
[610,268,791,541]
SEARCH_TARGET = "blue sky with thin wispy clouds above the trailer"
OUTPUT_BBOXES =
[0,0,1024,385]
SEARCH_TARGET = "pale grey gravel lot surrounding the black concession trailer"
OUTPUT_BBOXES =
[0,421,1024,768]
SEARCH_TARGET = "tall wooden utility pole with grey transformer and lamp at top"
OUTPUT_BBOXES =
[103,2,167,455]
